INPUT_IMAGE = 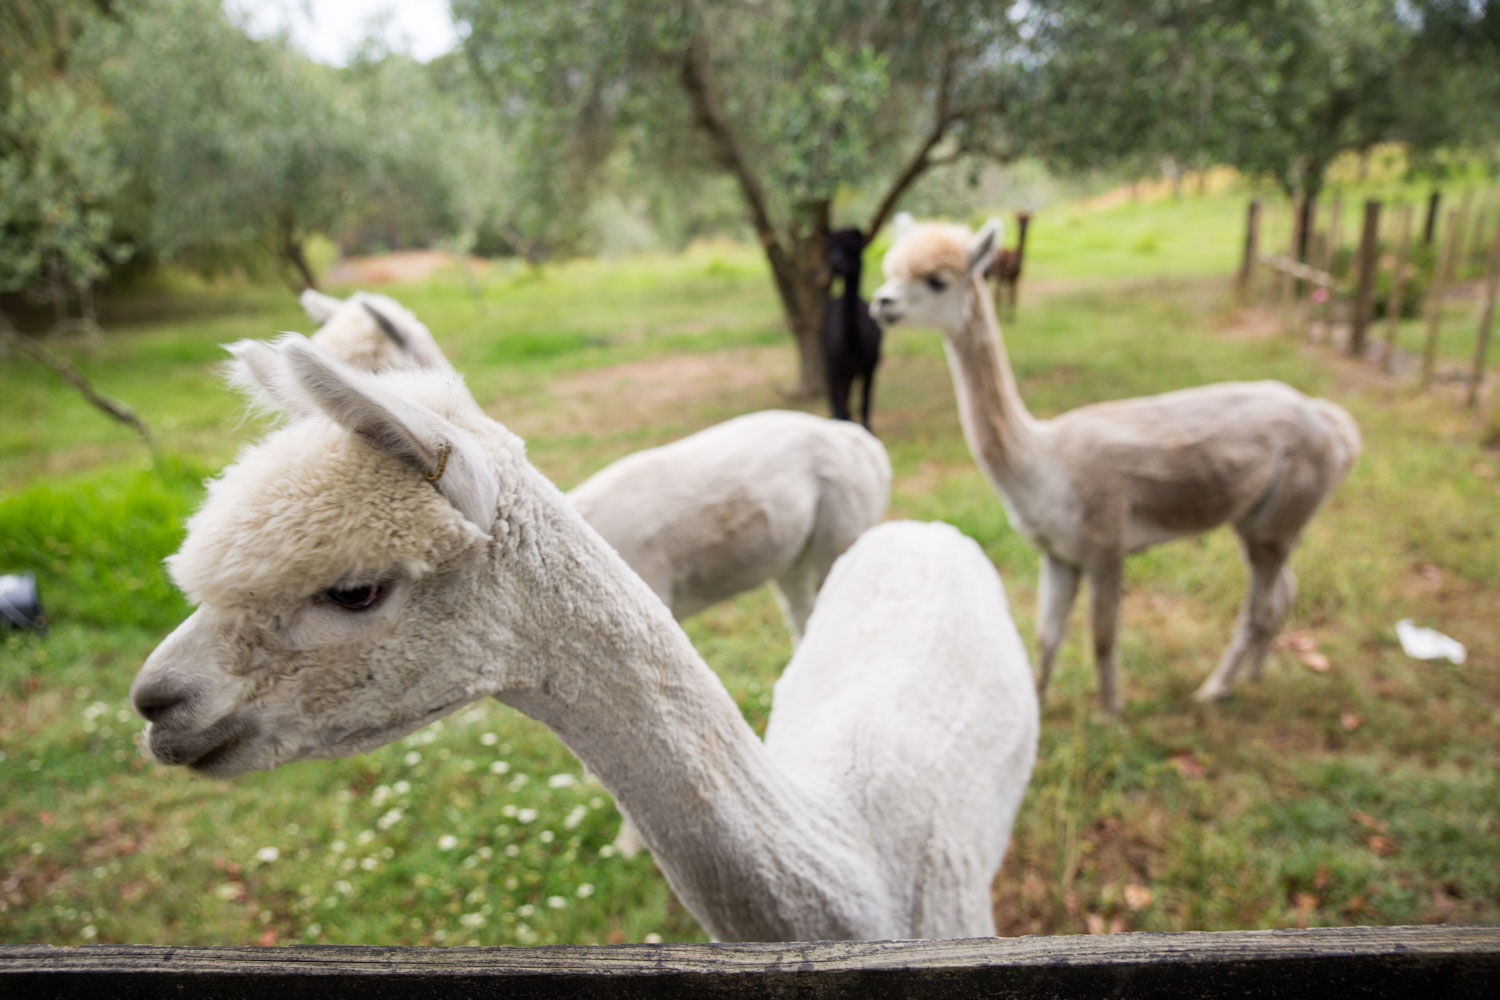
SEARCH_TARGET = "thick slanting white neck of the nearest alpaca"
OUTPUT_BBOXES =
[491,471,884,940]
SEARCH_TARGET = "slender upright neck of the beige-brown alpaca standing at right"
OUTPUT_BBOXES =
[944,277,1046,498]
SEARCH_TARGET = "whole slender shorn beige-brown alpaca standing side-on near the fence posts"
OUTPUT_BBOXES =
[870,216,1359,714]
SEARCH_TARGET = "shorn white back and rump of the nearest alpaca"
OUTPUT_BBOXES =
[765,522,1040,937]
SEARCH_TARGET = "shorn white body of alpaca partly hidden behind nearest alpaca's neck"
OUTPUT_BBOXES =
[567,409,891,642]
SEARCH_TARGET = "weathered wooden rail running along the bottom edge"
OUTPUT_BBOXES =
[0,927,1500,1000]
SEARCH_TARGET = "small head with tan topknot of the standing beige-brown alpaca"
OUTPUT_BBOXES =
[870,216,1002,330]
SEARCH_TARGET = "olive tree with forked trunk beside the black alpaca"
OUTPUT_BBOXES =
[453,0,1020,394]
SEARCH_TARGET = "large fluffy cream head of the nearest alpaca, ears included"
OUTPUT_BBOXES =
[131,334,525,777]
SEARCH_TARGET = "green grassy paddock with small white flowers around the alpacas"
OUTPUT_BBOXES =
[0,185,1500,945]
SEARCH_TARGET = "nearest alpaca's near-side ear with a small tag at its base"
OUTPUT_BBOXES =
[276,334,500,534]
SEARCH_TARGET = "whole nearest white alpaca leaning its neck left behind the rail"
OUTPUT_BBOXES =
[132,336,1038,940]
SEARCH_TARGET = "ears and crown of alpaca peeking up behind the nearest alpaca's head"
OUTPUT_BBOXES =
[297,288,453,372]
